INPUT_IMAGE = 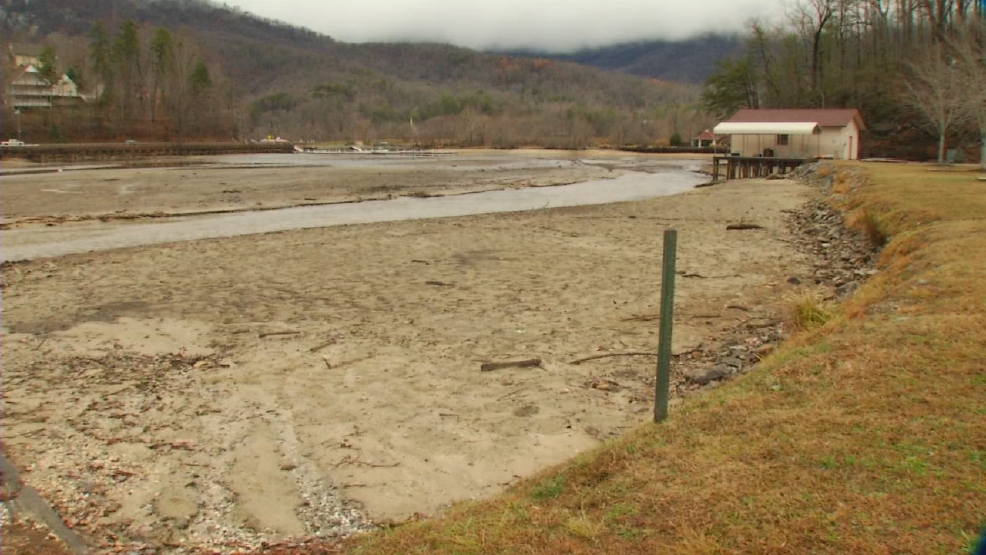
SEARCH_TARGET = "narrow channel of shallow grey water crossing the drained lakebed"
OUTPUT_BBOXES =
[0,162,707,262]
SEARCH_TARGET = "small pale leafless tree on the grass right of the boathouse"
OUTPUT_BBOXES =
[904,44,968,164]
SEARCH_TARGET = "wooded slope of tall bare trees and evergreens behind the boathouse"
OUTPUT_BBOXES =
[703,0,986,159]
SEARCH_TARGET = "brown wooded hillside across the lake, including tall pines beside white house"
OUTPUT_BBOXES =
[0,0,711,147]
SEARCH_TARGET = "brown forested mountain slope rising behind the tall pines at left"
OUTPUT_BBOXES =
[0,0,708,146]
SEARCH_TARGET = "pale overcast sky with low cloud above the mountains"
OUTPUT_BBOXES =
[218,0,784,51]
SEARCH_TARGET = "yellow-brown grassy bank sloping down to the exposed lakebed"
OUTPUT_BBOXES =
[350,165,986,555]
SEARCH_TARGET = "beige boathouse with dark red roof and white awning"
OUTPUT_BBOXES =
[713,108,866,160]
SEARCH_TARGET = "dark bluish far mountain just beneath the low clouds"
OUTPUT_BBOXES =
[509,34,743,84]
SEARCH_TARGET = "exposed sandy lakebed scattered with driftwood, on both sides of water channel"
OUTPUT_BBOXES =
[0,152,809,553]
